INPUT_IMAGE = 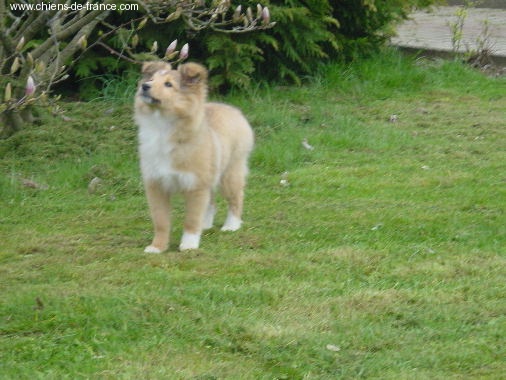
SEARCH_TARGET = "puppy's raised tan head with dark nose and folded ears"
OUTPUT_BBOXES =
[136,61,207,115]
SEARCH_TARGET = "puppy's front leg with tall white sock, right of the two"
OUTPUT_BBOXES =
[179,189,211,251]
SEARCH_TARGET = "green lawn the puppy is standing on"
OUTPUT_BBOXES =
[0,52,506,380]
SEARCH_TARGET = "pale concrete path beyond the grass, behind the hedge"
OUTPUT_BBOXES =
[392,5,506,65]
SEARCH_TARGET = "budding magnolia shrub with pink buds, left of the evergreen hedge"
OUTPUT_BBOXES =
[0,0,271,134]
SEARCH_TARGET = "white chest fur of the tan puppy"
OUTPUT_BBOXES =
[135,112,197,192]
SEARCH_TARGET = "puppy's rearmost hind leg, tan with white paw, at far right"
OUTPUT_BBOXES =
[221,161,248,231]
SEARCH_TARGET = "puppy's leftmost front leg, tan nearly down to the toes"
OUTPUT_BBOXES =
[144,182,170,253]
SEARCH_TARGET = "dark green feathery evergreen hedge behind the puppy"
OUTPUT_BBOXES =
[75,0,438,95]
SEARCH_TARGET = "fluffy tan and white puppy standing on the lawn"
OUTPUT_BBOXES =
[135,62,253,253]
